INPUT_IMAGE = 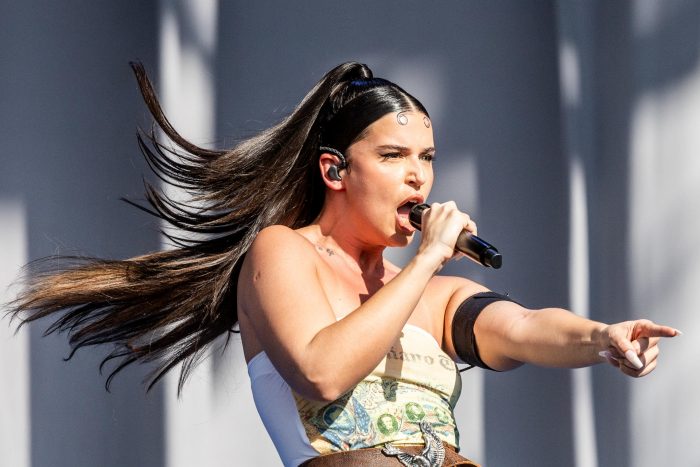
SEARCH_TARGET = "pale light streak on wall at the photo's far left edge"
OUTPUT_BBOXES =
[0,200,30,467]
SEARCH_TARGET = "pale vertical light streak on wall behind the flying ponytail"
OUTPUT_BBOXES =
[159,0,220,467]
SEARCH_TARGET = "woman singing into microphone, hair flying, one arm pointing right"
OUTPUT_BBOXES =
[8,63,678,466]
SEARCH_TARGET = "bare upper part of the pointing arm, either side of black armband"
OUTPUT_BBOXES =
[444,286,529,371]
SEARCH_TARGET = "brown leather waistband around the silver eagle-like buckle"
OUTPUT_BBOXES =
[299,443,480,467]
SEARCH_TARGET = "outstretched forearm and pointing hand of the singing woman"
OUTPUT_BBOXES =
[474,301,679,377]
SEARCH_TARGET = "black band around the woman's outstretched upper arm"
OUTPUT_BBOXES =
[452,292,517,370]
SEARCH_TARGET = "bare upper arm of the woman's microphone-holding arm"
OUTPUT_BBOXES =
[238,226,336,384]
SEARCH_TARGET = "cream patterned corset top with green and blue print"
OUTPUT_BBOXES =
[294,325,462,454]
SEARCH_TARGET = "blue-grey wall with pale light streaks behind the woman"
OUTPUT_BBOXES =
[0,0,700,466]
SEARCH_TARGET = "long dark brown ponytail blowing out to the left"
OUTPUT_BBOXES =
[10,62,427,392]
